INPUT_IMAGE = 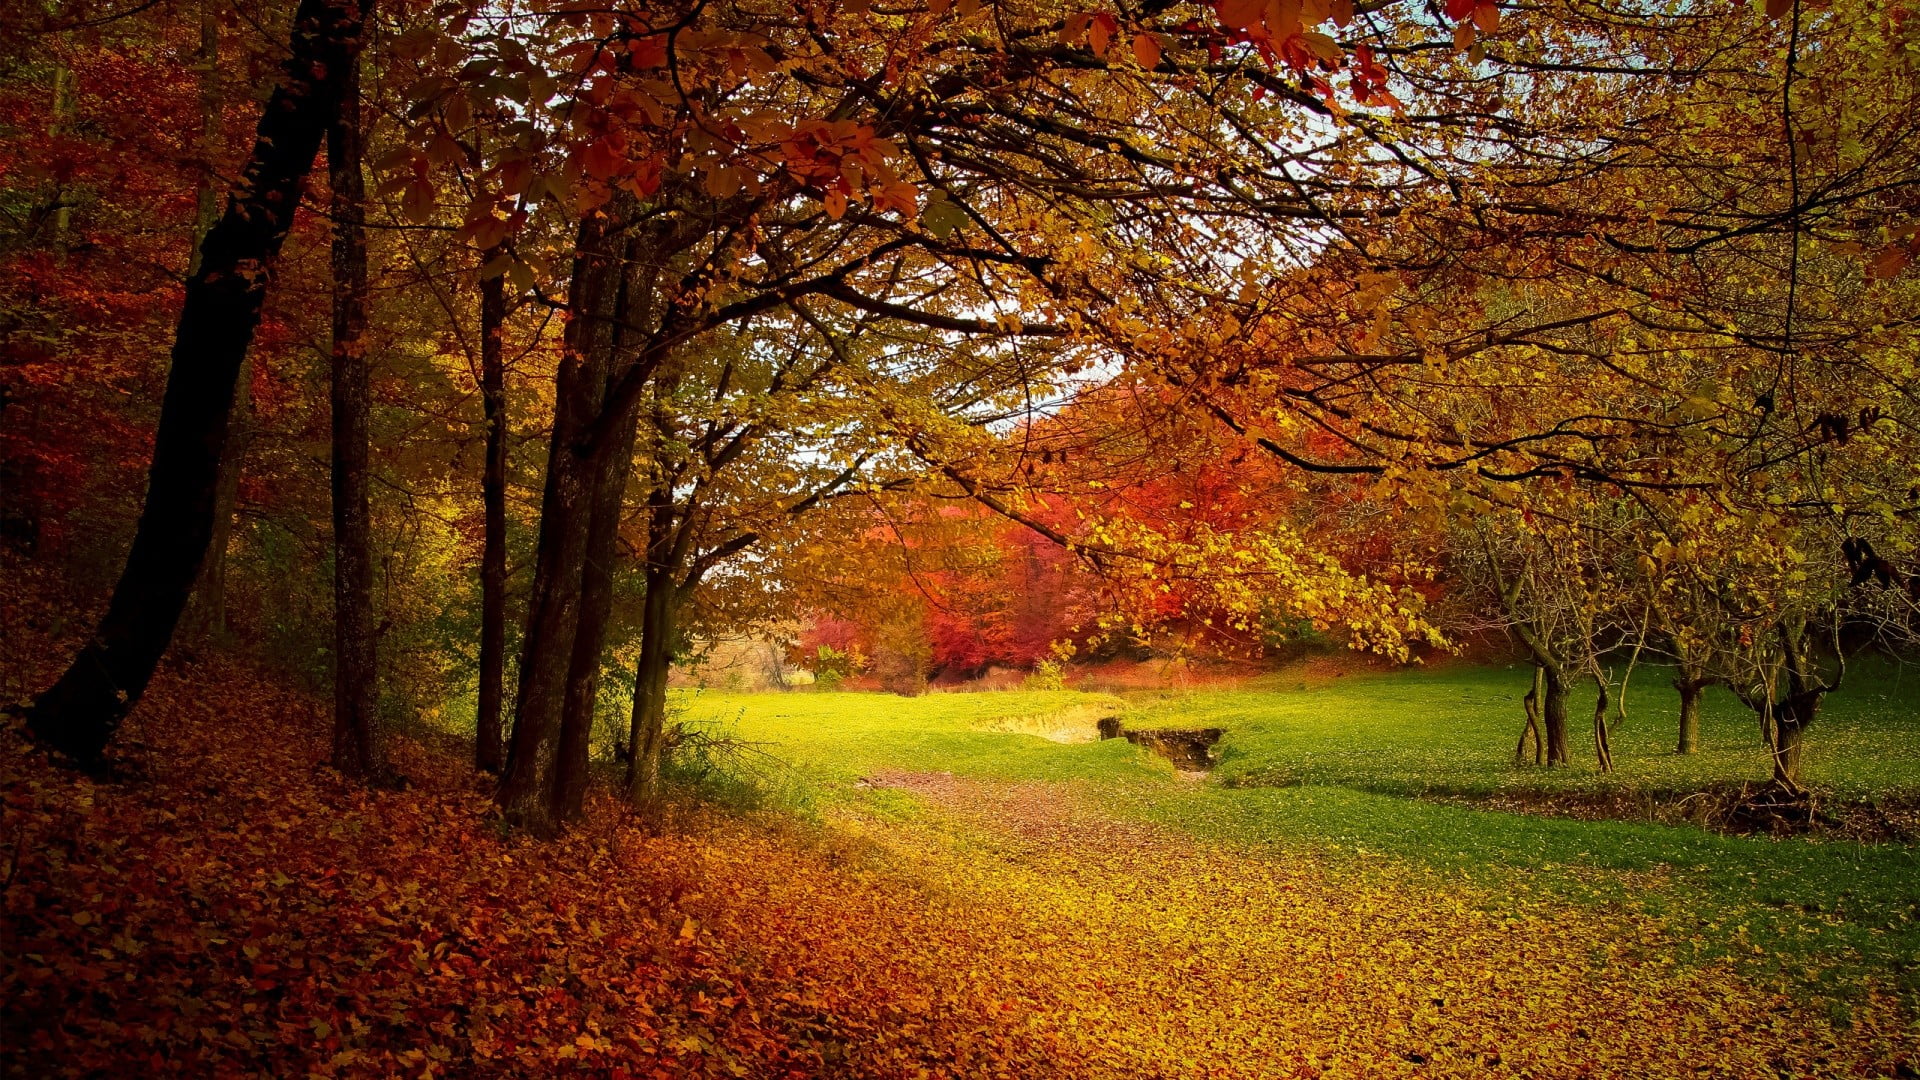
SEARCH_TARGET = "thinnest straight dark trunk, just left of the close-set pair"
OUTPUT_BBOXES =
[474,250,507,773]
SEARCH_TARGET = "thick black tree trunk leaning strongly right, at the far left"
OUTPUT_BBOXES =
[29,0,372,763]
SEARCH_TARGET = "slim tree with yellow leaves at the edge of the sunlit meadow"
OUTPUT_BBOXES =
[628,306,1012,809]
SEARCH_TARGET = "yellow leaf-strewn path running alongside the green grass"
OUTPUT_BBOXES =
[874,773,1920,1078]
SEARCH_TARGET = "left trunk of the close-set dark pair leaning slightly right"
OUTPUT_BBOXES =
[495,200,624,834]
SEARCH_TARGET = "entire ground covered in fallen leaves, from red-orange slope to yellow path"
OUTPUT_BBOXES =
[0,591,1920,1078]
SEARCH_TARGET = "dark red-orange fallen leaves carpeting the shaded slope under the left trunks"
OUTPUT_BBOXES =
[0,568,1082,1078]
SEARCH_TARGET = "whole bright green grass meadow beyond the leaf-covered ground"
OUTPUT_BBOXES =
[676,669,1920,994]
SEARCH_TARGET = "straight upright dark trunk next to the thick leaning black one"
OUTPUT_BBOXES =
[326,50,380,778]
